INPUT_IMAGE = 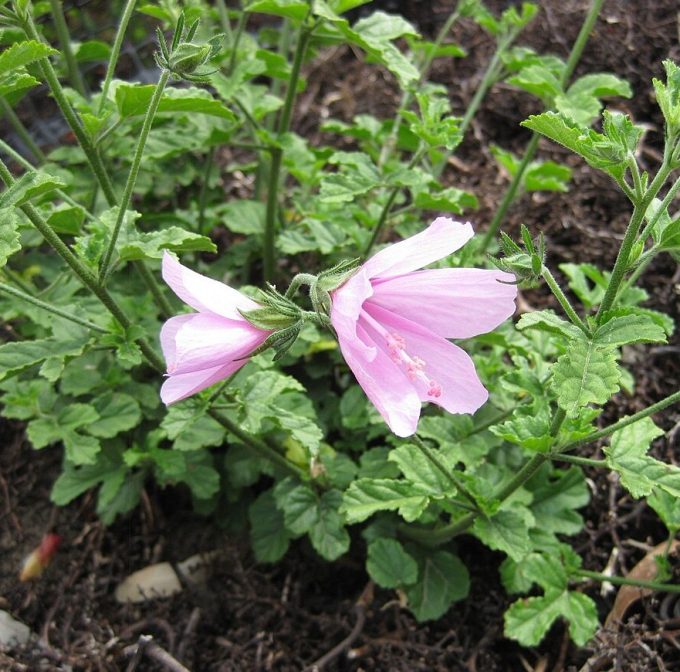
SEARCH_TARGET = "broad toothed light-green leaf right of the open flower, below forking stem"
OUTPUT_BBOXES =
[552,341,621,418]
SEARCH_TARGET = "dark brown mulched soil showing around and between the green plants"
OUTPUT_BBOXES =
[0,0,680,672]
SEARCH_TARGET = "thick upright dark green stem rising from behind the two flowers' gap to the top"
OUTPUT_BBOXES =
[262,21,314,282]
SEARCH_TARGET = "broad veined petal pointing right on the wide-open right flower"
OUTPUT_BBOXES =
[368,268,517,338]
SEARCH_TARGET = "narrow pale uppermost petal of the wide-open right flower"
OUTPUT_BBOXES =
[363,217,474,278]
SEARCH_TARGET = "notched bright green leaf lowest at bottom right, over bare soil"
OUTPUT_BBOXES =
[505,590,599,646]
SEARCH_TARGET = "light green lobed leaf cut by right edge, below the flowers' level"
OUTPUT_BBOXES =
[604,418,680,497]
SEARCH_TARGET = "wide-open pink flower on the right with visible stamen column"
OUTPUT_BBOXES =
[331,217,517,436]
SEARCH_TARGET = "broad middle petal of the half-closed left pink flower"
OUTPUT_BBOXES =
[161,313,270,375]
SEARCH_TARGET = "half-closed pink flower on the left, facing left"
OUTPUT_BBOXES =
[161,252,271,404]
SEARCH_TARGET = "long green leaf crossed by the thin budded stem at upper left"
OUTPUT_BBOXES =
[111,81,236,121]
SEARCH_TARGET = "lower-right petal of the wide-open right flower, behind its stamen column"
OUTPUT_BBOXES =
[364,305,489,413]
